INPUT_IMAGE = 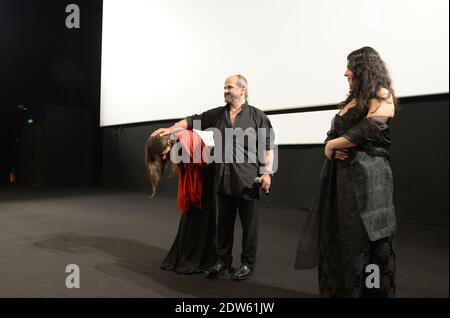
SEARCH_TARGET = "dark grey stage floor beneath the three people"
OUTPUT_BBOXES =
[0,185,449,298]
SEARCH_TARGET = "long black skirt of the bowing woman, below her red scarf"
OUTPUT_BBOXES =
[161,164,216,274]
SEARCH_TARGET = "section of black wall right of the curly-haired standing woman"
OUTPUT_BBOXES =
[391,94,449,226]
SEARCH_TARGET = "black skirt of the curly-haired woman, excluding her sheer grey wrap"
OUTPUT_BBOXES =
[318,160,395,298]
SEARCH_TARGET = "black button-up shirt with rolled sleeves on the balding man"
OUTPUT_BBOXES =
[186,103,274,200]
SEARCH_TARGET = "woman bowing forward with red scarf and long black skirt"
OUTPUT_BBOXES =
[145,130,216,274]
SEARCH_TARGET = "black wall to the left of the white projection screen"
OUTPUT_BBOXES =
[0,0,102,185]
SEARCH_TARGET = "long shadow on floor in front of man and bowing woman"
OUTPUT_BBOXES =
[34,233,316,298]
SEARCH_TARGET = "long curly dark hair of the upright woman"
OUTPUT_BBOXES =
[339,46,397,114]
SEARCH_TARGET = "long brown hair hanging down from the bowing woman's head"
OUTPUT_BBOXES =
[144,135,176,198]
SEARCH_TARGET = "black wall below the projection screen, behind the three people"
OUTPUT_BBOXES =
[101,94,449,224]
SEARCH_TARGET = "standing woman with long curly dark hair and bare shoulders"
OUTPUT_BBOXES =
[296,47,397,297]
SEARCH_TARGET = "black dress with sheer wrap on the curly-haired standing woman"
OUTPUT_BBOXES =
[296,108,396,297]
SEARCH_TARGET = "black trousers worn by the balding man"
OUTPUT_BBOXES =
[217,194,258,269]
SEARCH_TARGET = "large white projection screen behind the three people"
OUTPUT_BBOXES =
[100,0,449,144]
